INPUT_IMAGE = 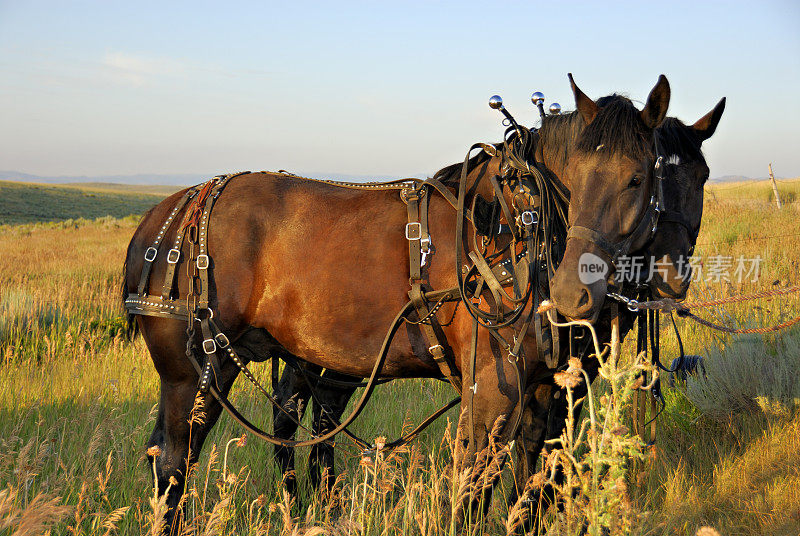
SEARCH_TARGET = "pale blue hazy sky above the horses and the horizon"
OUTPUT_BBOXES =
[0,0,800,177]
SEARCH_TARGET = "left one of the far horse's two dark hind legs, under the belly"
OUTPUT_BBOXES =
[272,364,313,496]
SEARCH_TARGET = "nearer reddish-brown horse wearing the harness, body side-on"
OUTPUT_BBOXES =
[125,73,669,522]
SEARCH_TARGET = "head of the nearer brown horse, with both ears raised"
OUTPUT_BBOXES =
[550,75,670,320]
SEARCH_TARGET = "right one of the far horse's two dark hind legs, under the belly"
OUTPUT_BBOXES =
[308,370,359,492]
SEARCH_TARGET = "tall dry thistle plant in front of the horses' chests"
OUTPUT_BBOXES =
[540,316,653,535]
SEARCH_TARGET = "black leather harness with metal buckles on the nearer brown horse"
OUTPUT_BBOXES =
[125,123,660,448]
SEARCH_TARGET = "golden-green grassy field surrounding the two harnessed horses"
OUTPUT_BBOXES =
[0,182,800,536]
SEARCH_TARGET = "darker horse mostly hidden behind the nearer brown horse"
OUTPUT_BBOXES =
[274,97,725,500]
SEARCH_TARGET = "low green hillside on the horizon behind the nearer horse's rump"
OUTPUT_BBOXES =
[0,181,177,224]
